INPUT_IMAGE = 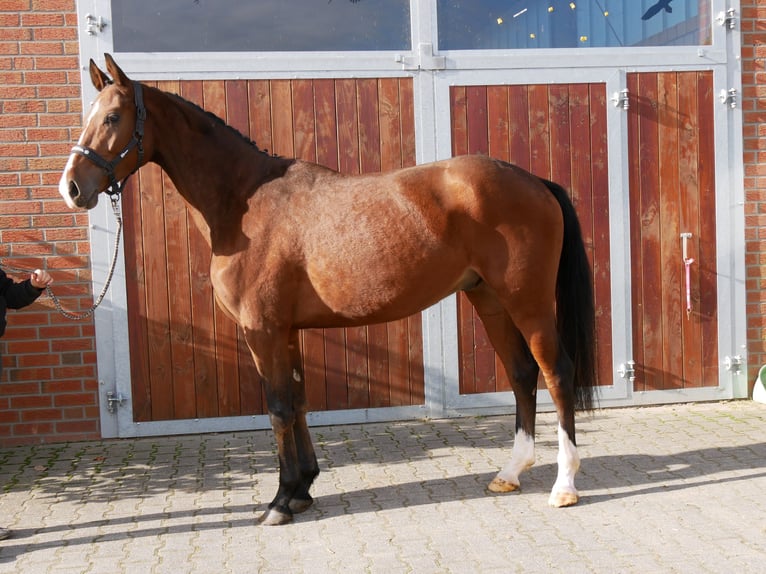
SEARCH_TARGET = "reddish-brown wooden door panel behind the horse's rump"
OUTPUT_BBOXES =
[450,83,613,395]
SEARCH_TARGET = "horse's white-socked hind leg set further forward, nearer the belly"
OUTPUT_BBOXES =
[466,290,539,498]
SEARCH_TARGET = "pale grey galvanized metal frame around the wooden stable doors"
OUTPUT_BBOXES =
[77,0,747,437]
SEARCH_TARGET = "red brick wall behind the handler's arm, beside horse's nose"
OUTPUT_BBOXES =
[0,0,99,446]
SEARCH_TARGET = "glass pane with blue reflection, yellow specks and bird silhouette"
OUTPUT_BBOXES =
[437,0,711,50]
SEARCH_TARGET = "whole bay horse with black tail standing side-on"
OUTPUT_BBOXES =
[59,54,595,525]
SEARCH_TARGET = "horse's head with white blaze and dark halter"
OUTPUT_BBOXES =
[59,54,146,209]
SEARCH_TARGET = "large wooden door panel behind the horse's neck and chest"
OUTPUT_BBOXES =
[123,78,424,422]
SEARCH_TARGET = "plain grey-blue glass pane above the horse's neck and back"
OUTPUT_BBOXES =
[112,0,411,52]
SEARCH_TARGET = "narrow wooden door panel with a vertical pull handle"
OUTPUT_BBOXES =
[627,71,719,391]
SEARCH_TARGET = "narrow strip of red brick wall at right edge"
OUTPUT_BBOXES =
[740,0,766,396]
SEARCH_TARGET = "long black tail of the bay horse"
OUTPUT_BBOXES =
[543,180,597,411]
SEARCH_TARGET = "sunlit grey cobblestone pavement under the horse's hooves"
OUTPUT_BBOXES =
[0,401,766,574]
